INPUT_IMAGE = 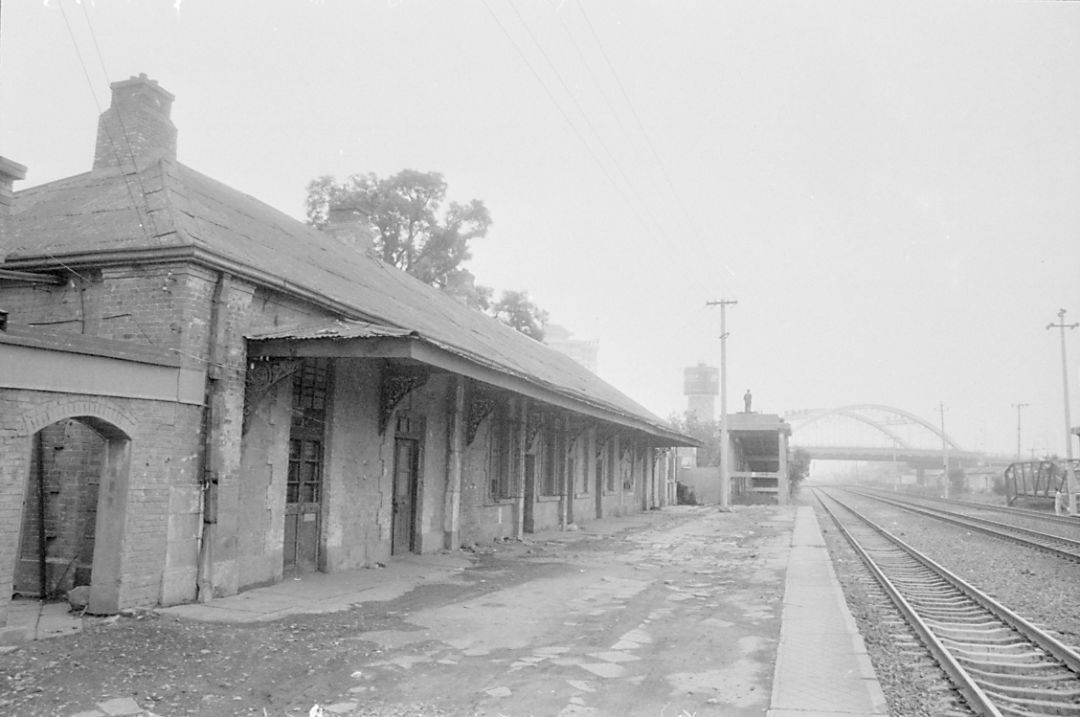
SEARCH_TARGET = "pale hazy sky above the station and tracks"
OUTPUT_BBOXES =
[0,0,1080,454]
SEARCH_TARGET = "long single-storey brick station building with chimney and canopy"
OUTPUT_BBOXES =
[0,76,696,637]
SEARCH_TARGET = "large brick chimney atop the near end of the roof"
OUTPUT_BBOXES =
[94,75,176,171]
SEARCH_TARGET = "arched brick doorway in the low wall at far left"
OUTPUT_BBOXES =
[12,416,131,614]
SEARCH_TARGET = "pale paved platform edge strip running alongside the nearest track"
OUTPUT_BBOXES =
[766,505,889,717]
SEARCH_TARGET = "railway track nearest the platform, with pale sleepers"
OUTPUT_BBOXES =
[815,489,1080,717]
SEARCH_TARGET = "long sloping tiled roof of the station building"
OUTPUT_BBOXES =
[0,160,677,437]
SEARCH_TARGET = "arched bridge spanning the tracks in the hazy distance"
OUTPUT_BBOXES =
[785,404,982,468]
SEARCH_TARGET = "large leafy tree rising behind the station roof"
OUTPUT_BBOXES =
[306,170,491,309]
